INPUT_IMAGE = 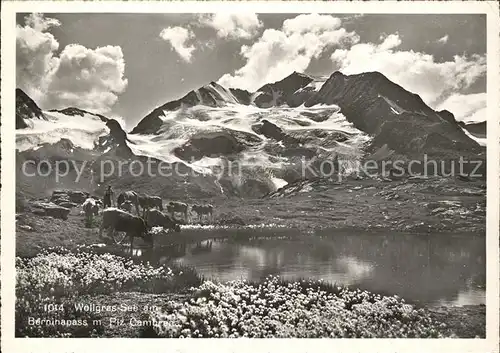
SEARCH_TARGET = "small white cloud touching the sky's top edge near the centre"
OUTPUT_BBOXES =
[198,12,263,39]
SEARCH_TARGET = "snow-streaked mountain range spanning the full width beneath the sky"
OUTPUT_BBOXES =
[16,71,486,199]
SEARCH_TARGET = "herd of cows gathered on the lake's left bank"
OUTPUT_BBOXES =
[77,191,214,249]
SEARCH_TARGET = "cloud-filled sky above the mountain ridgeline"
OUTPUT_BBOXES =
[16,13,486,130]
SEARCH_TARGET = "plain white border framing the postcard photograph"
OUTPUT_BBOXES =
[1,1,500,353]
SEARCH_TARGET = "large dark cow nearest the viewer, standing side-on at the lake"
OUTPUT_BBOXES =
[99,207,154,252]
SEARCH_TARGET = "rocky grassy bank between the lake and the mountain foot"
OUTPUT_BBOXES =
[16,177,486,256]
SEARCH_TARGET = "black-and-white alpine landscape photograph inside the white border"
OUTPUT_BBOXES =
[2,2,498,344]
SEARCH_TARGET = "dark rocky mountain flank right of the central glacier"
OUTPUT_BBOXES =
[305,72,486,172]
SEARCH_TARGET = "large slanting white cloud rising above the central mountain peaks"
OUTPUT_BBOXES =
[219,14,359,91]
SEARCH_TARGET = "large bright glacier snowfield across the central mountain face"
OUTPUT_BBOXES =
[128,101,370,175]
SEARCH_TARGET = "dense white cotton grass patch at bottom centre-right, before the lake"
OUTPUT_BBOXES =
[149,277,445,338]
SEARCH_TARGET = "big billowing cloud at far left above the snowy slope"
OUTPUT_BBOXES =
[16,14,127,112]
